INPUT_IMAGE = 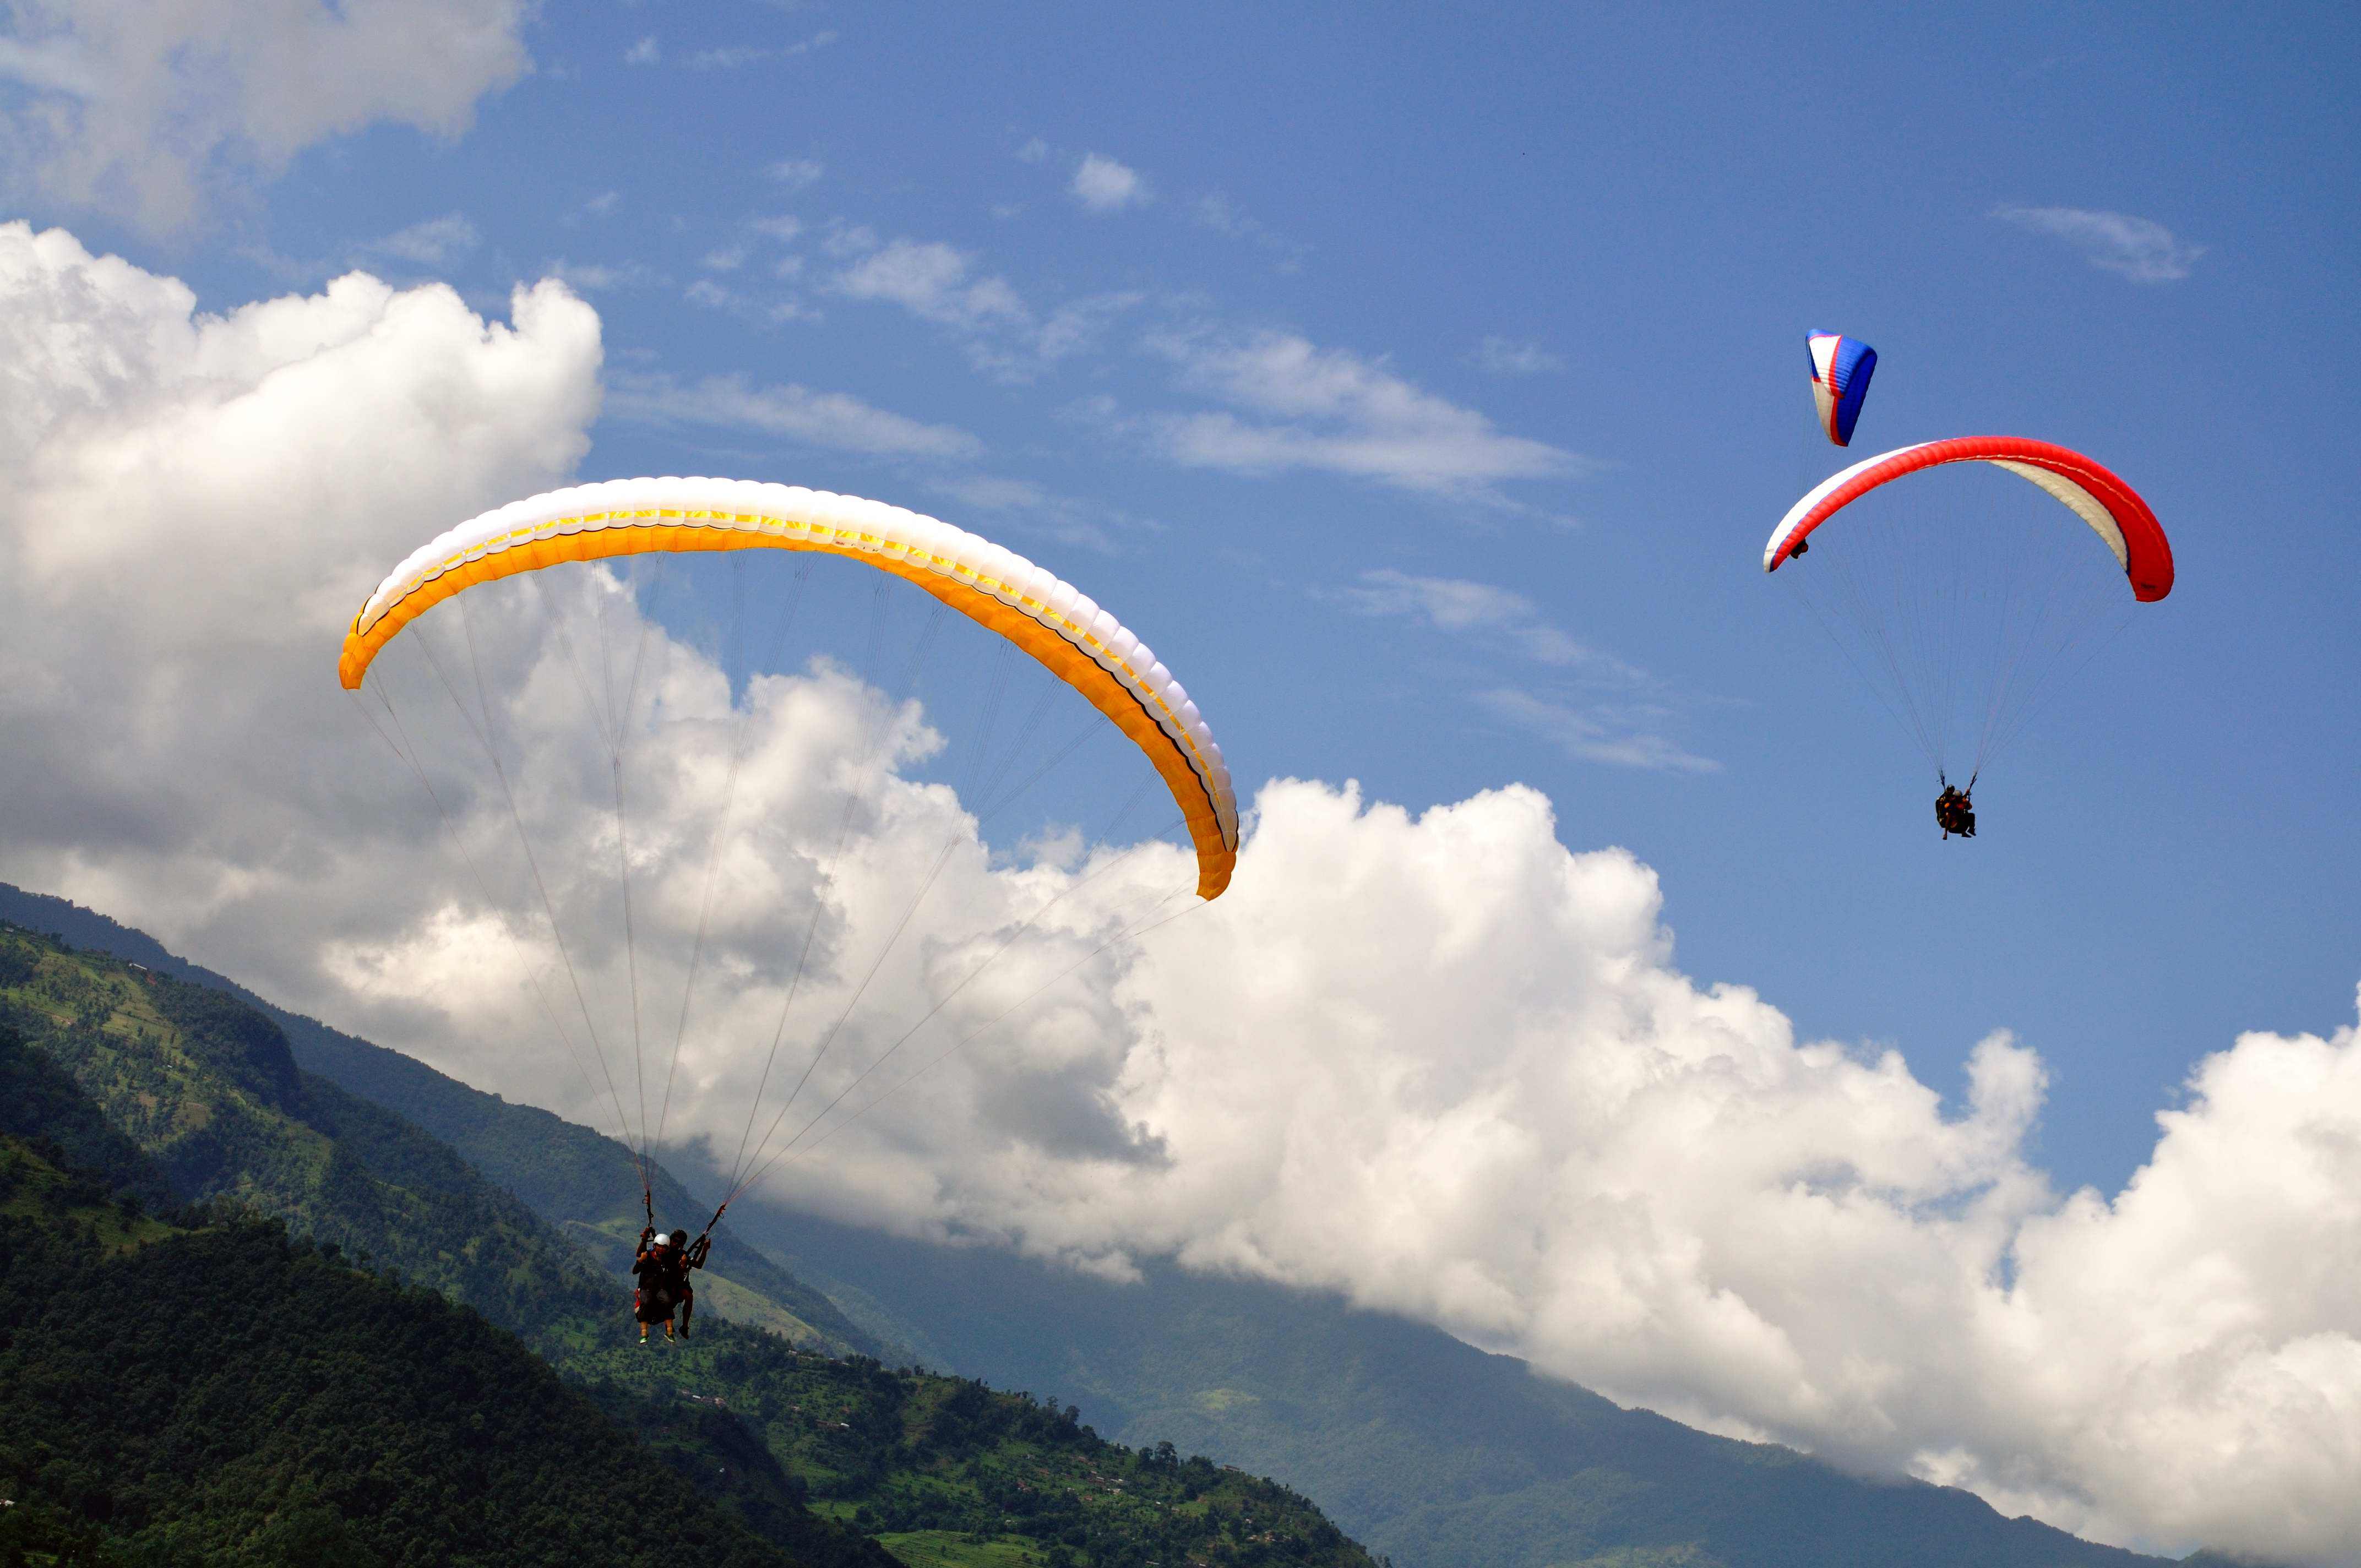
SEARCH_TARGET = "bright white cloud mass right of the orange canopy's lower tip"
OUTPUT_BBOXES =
[1105,807,2361,1561]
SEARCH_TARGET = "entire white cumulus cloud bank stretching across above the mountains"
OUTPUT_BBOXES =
[0,224,2361,1563]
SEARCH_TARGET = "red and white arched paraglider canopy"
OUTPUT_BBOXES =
[1764,434,2172,602]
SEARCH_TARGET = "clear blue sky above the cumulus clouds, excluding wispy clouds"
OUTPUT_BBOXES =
[106,5,2361,1185]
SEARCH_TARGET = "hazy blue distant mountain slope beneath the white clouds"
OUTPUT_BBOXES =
[722,1211,2165,1568]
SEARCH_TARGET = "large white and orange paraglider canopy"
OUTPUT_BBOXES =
[335,480,1237,897]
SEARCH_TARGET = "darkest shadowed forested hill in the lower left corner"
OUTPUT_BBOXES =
[0,1067,845,1568]
